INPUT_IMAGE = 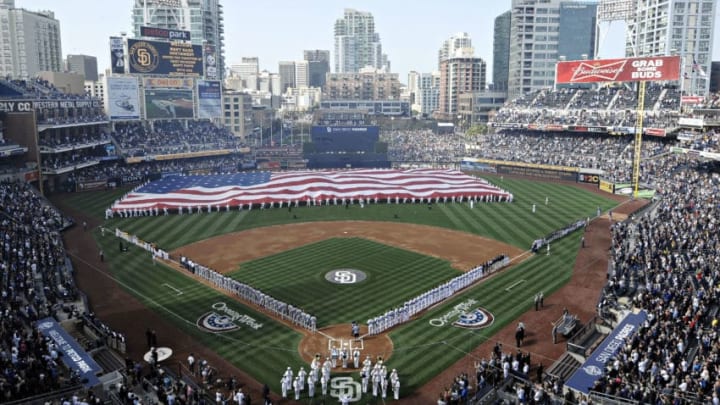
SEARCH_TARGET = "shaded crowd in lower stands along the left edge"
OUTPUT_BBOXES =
[0,182,84,402]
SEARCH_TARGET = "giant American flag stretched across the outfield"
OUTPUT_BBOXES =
[111,169,512,212]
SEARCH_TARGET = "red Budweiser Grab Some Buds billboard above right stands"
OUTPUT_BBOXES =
[555,56,680,84]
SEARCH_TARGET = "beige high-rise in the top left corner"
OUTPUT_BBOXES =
[0,0,61,78]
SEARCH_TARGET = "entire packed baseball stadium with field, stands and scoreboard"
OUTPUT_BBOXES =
[0,6,720,405]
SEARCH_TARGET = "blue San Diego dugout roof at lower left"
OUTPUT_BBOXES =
[36,317,102,388]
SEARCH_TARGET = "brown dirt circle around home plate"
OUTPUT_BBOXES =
[298,323,393,373]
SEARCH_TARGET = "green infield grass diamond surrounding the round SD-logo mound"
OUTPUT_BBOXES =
[230,238,461,327]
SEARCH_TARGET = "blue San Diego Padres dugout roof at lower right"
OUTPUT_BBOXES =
[565,311,647,394]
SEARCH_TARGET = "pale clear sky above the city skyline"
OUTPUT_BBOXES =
[15,0,720,82]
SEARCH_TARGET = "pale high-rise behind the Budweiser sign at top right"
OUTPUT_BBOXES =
[625,0,717,95]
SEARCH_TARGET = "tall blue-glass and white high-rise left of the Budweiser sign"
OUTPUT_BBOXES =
[508,0,595,99]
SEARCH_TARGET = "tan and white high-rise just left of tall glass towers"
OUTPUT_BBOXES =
[436,48,487,120]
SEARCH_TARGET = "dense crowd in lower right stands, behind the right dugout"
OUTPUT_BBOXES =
[593,157,720,403]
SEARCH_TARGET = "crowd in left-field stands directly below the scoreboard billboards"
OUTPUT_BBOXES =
[112,120,245,156]
